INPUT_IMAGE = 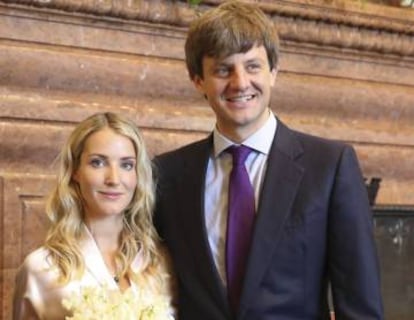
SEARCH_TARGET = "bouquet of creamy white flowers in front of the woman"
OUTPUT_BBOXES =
[62,287,174,320]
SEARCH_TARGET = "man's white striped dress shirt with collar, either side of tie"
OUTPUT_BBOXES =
[204,113,277,284]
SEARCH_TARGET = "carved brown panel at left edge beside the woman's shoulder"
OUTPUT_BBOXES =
[0,174,53,319]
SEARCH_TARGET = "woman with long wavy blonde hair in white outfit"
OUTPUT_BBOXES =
[13,113,172,320]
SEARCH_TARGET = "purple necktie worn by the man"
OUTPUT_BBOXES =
[226,145,255,313]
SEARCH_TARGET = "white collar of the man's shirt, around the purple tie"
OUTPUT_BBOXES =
[213,112,277,158]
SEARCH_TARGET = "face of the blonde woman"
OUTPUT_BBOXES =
[73,128,137,219]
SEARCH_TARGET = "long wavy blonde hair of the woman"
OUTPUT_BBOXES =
[45,112,167,289]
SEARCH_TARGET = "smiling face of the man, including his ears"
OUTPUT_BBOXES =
[193,46,277,142]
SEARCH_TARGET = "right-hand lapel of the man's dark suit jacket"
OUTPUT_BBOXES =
[240,121,304,318]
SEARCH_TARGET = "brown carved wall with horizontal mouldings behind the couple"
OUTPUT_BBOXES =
[0,0,414,319]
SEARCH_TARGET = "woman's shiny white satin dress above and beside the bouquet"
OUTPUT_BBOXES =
[13,227,172,320]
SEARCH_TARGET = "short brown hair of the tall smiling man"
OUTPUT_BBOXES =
[185,1,279,79]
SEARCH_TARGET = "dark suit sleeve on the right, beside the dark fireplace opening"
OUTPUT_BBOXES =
[328,147,383,320]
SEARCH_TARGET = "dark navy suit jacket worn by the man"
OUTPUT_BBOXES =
[155,121,383,320]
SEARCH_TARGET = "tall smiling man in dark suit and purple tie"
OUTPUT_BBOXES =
[155,2,383,320]
